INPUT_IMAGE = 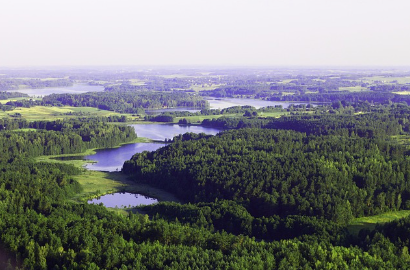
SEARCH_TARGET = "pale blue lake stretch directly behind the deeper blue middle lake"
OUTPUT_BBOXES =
[131,124,222,141]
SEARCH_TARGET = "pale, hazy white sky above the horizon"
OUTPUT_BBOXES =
[0,0,410,66]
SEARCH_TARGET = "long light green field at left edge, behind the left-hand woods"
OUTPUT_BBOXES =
[0,106,131,121]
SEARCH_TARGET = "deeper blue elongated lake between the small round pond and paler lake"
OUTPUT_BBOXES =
[84,143,166,172]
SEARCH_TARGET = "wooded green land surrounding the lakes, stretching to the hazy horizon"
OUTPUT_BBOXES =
[0,69,410,269]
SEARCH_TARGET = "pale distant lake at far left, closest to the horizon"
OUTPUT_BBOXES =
[6,84,104,97]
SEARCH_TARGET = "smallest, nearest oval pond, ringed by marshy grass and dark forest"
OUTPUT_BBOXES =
[88,192,158,208]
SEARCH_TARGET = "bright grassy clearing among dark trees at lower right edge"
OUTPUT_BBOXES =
[347,210,410,235]
